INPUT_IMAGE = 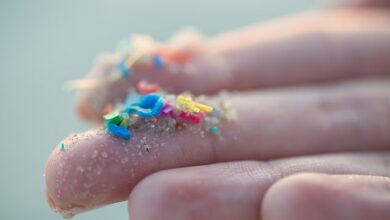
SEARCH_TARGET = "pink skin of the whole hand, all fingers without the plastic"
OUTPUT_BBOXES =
[45,1,390,220]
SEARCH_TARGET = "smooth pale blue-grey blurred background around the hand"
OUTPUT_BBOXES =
[0,0,325,220]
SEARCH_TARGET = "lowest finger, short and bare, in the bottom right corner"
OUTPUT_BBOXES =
[262,174,390,220]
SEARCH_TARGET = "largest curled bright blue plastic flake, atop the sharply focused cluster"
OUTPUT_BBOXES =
[124,93,165,118]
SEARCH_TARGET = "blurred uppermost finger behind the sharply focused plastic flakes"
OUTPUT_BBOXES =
[77,8,390,120]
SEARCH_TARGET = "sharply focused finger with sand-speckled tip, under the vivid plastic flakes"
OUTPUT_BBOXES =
[46,79,390,216]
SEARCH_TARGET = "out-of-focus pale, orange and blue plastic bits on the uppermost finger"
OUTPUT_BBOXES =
[65,27,202,89]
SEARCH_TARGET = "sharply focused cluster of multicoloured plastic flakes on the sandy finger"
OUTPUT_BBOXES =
[103,88,232,140]
